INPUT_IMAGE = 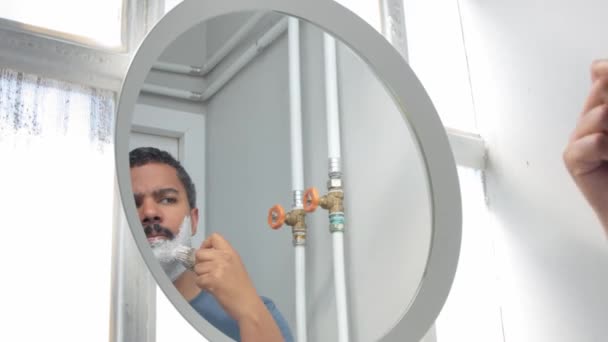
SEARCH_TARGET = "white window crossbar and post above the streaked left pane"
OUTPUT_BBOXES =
[0,0,164,92]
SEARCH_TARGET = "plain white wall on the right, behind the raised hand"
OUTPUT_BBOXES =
[461,0,608,342]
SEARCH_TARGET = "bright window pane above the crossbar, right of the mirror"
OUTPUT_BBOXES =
[404,0,477,133]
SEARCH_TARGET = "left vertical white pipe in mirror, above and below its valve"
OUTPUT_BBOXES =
[288,18,307,342]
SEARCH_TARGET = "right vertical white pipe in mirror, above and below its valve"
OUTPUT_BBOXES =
[323,34,349,342]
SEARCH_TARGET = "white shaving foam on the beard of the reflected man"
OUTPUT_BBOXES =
[150,216,192,282]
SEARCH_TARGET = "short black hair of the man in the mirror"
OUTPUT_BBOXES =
[129,147,196,209]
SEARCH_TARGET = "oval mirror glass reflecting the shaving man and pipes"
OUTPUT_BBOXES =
[130,12,432,341]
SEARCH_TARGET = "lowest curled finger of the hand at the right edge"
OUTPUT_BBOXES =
[564,133,608,176]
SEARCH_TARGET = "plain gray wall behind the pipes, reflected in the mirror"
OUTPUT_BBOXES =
[203,13,430,341]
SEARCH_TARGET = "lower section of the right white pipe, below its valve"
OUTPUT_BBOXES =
[331,232,349,342]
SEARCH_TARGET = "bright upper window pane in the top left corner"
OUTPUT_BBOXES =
[0,0,123,48]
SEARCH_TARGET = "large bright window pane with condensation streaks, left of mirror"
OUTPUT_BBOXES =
[0,69,115,342]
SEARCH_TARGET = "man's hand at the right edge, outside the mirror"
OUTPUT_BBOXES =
[564,60,608,234]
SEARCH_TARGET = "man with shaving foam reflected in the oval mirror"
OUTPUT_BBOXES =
[129,147,293,342]
